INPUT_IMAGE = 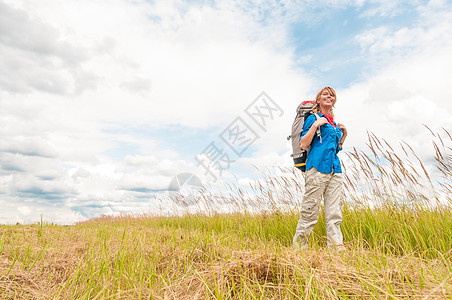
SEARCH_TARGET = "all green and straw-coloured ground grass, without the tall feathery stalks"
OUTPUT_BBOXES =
[0,207,452,299]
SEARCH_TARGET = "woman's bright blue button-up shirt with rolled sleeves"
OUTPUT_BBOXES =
[300,113,342,174]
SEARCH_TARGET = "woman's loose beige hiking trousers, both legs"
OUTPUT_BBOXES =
[293,168,343,248]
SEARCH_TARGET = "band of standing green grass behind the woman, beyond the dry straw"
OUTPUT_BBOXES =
[150,206,452,258]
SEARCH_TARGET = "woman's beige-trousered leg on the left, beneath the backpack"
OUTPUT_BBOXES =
[293,168,325,249]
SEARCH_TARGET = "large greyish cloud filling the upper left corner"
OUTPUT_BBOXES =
[0,2,95,94]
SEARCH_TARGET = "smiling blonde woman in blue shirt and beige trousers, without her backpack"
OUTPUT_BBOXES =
[293,87,347,250]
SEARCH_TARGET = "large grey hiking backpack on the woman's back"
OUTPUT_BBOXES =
[287,101,321,172]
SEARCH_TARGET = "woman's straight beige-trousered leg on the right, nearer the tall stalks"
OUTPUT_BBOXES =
[323,173,344,247]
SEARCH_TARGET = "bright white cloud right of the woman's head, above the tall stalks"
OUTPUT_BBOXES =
[337,1,452,159]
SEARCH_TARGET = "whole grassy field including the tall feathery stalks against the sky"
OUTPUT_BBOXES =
[0,131,452,299]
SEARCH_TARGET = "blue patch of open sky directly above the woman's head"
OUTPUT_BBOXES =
[289,1,419,88]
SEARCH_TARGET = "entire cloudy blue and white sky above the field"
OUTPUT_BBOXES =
[0,0,452,225]
